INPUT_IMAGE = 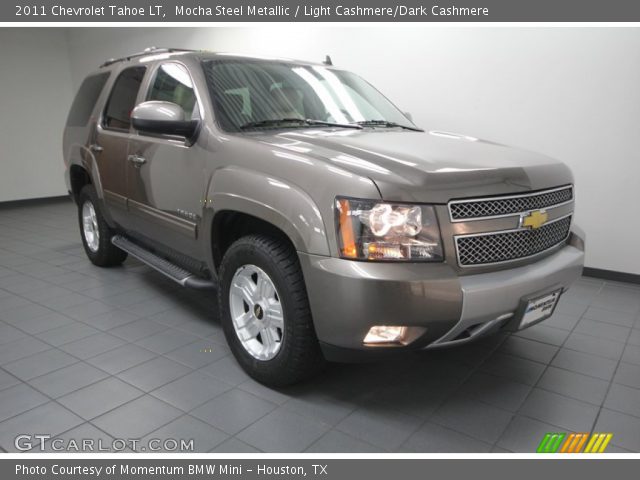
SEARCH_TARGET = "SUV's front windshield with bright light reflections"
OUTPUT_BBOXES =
[203,59,416,131]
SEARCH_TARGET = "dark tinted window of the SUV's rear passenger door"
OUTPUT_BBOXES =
[104,67,146,130]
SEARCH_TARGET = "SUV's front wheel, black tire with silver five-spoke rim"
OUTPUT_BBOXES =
[218,235,325,387]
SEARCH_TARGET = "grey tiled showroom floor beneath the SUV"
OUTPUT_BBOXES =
[0,201,640,452]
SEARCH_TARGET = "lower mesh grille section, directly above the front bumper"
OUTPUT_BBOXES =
[455,216,571,267]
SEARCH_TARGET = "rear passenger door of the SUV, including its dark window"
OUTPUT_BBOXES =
[90,66,146,229]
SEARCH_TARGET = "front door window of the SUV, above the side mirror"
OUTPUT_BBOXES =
[147,63,198,120]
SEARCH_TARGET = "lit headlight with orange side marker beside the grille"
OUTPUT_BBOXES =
[336,197,443,262]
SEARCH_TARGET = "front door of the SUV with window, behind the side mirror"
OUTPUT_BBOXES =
[127,60,206,258]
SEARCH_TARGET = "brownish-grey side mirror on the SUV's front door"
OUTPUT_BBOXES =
[131,100,199,138]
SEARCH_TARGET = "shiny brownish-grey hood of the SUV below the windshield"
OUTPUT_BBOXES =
[257,129,573,203]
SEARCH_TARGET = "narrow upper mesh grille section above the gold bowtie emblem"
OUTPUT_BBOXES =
[449,186,573,221]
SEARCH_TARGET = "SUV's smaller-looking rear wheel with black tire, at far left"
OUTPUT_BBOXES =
[78,185,127,267]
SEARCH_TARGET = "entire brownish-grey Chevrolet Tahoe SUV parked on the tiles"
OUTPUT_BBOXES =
[64,49,584,385]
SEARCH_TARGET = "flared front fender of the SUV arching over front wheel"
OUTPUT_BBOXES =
[203,166,330,270]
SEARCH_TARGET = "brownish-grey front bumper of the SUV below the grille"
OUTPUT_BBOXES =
[300,232,584,361]
